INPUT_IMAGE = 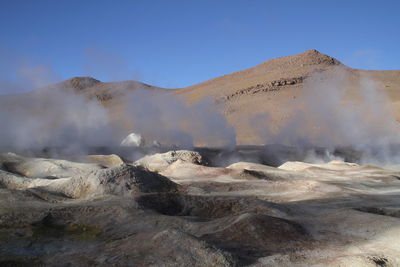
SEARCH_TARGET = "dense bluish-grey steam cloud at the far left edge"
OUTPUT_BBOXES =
[0,88,116,152]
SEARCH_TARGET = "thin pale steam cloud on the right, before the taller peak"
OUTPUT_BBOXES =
[253,67,400,161]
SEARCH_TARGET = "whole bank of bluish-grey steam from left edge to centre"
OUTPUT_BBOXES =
[0,55,236,152]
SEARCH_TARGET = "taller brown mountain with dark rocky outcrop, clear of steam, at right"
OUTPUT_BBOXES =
[174,50,400,144]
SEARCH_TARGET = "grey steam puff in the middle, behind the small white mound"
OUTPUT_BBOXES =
[123,89,236,148]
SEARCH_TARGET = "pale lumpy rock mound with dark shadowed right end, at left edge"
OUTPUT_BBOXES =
[0,155,178,198]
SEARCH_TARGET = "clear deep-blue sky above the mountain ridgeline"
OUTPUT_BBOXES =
[0,0,400,90]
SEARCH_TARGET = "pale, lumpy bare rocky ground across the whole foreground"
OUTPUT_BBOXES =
[0,151,400,266]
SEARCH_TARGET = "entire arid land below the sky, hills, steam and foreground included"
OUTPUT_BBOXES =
[0,50,400,266]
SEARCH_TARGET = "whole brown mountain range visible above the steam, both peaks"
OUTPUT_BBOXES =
[0,50,400,147]
